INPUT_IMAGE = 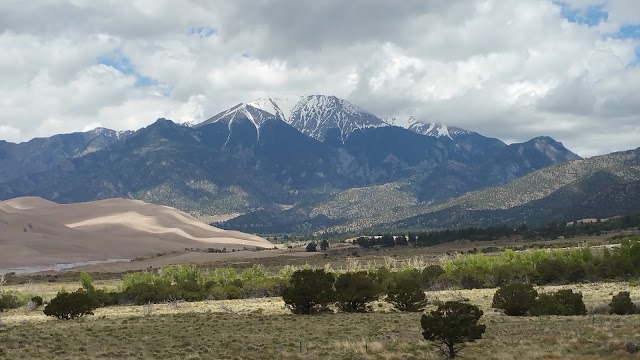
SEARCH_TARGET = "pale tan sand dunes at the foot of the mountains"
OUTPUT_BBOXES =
[0,197,273,269]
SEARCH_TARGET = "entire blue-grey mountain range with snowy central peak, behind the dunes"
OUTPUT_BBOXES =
[0,95,579,233]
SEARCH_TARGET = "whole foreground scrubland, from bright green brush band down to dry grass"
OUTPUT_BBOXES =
[0,238,640,359]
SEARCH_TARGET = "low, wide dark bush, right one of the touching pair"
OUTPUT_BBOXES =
[529,289,587,316]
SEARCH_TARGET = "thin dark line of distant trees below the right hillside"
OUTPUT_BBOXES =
[353,214,640,248]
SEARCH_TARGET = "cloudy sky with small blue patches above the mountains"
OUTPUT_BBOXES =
[0,0,640,157]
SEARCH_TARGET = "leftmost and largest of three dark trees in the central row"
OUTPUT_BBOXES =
[282,269,335,315]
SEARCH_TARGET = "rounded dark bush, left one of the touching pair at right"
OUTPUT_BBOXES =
[491,283,538,316]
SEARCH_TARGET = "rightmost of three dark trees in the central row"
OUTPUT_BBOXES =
[387,271,427,311]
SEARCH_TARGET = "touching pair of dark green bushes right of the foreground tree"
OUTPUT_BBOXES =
[491,283,587,316]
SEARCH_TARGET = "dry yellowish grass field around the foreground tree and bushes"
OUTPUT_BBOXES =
[0,282,640,359]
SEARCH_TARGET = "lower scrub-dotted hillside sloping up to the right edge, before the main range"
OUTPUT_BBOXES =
[380,145,640,228]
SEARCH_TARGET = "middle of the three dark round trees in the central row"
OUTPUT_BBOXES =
[335,271,382,312]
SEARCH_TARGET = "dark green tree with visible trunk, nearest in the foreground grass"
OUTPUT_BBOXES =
[420,301,486,359]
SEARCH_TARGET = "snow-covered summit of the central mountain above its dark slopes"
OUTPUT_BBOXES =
[196,95,388,141]
